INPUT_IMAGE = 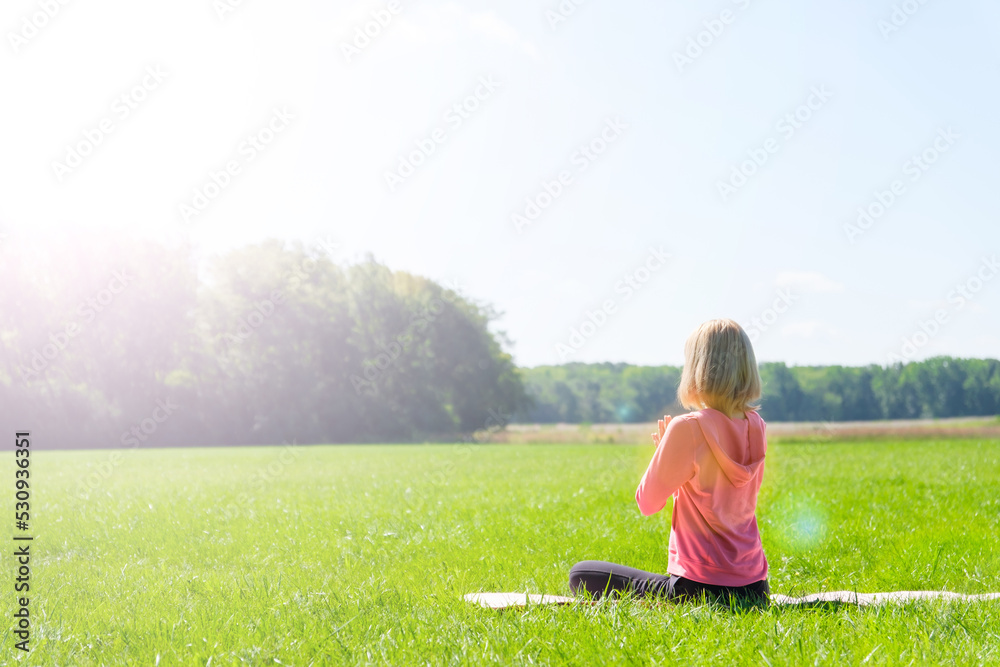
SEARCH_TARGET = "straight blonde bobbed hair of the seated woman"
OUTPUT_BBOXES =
[677,319,761,416]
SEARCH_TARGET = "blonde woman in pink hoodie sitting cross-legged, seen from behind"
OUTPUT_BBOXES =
[570,319,770,600]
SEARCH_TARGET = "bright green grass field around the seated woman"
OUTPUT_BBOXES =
[11,440,1000,665]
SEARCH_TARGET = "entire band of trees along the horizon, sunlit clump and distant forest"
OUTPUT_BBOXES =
[0,239,1000,448]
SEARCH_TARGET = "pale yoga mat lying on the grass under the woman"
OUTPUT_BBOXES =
[463,591,1000,609]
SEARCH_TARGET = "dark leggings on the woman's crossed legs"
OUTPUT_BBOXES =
[569,560,771,603]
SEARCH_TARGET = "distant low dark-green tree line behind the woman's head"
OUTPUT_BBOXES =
[518,357,1000,423]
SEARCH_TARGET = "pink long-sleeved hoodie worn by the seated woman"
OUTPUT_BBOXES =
[635,408,767,586]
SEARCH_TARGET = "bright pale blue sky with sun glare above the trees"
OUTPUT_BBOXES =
[0,0,1000,366]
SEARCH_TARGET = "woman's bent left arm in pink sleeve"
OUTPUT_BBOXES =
[635,419,698,516]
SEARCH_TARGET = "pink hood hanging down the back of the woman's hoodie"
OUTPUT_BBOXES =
[696,408,767,487]
